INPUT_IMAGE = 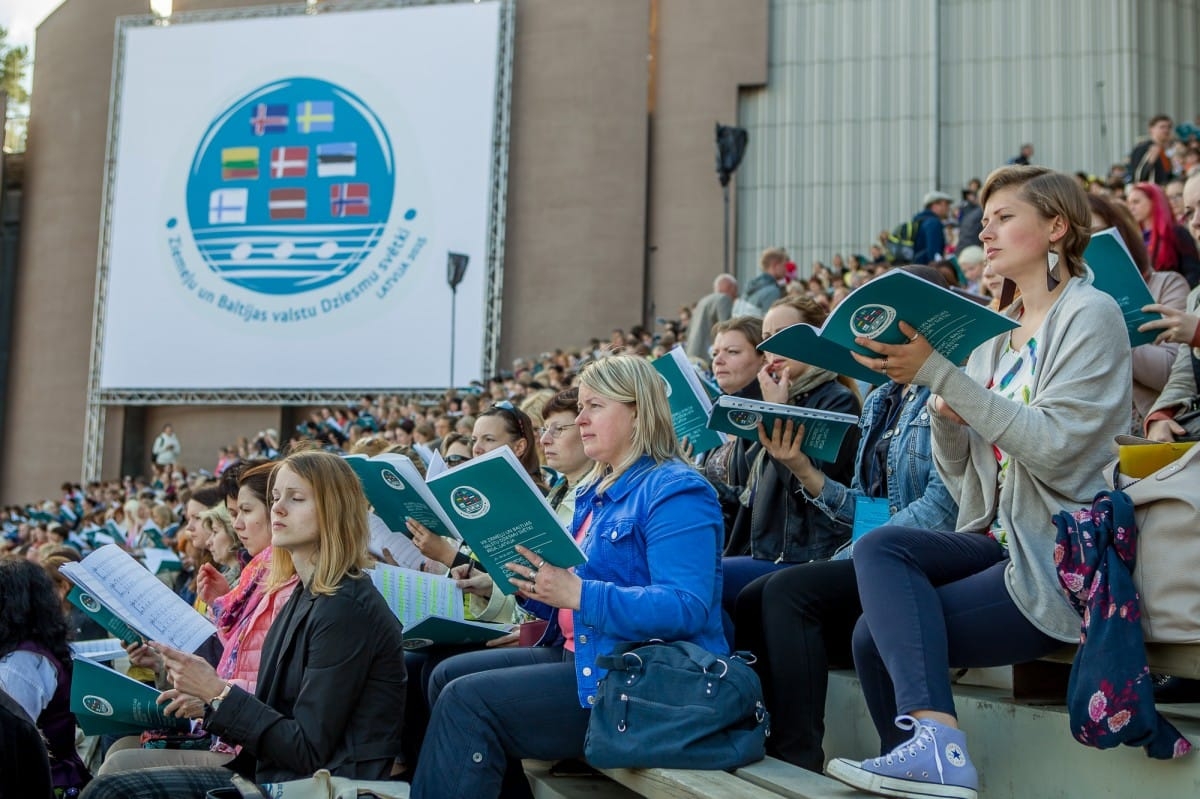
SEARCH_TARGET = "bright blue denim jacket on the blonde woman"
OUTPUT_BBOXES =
[524,457,728,708]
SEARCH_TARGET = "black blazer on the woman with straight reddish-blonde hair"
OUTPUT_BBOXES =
[205,568,406,782]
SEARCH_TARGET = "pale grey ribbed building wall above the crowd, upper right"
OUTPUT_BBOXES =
[737,0,1200,276]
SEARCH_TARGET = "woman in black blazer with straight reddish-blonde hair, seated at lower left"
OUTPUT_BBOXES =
[84,450,406,799]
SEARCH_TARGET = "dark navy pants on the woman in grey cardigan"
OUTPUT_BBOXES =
[852,523,1062,752]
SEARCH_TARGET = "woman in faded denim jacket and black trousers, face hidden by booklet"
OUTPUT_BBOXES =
[734,266,958,771]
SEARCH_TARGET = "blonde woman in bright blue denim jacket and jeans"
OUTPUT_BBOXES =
[412,355,727,799]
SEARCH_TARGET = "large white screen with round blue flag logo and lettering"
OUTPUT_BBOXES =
[94,1,502,392]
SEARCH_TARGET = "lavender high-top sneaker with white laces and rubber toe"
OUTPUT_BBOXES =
[826,716,979,799]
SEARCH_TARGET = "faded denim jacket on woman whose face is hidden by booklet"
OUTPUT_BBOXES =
[805,383,959,554]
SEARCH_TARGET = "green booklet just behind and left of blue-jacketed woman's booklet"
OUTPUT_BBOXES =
[346,452,462,539]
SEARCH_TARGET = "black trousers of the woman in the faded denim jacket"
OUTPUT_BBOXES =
[736,560,862,771]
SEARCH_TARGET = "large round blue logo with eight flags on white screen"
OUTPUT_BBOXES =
[187,78,396,295]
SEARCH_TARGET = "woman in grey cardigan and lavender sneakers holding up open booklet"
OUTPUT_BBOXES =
[828,166,1133,799]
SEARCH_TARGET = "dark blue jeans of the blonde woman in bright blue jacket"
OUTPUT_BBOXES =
[410,647,590,799]
